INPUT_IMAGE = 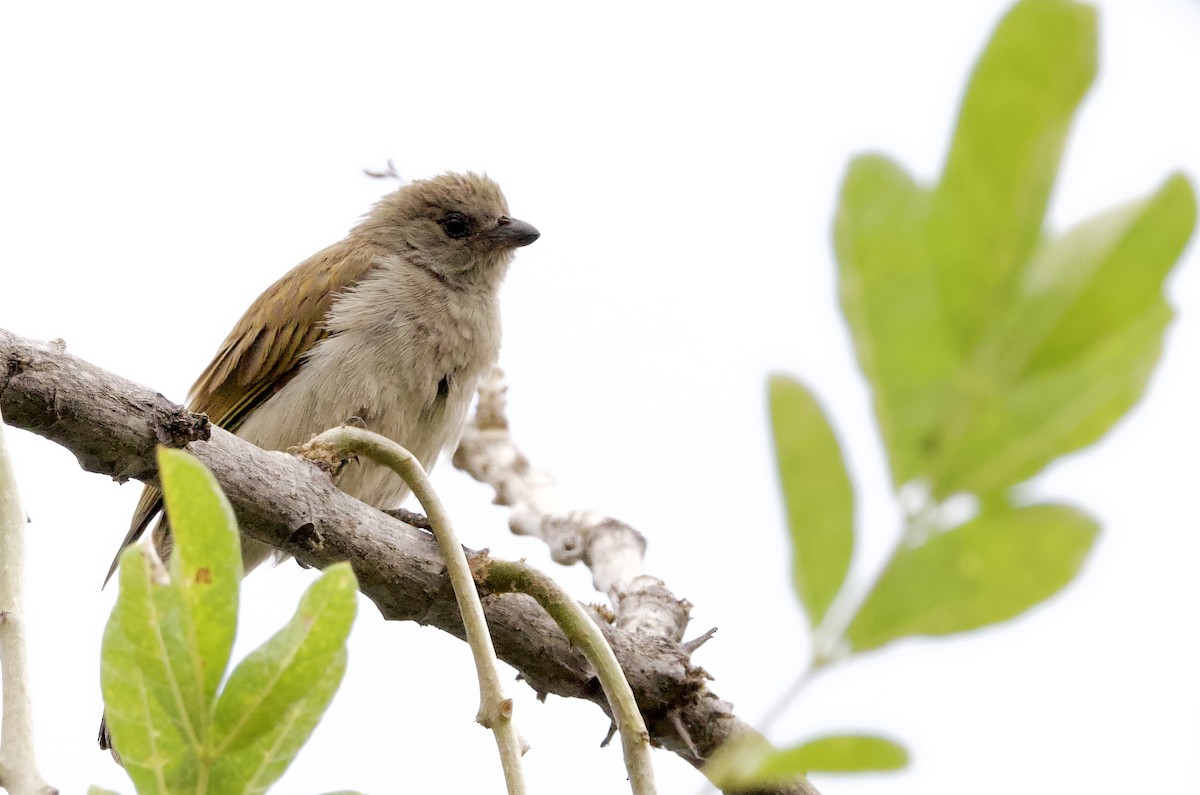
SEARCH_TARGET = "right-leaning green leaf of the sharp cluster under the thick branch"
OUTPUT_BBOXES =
[212,563,358,793]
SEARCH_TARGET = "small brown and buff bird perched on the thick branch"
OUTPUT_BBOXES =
[100,172,540,755]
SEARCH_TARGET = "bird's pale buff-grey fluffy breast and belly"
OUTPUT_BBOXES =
[239,261,499,508]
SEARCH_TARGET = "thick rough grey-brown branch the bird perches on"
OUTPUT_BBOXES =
[0,329,816,795]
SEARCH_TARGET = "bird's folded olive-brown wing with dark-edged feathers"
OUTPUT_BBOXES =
[104,238,379,584]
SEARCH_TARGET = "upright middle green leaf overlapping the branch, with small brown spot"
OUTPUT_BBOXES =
[158,447,241,716]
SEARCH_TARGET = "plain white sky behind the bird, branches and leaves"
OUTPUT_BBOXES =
[0,0,1200,795]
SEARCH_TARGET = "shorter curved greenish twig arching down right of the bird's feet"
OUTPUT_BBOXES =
[475,558,656,795]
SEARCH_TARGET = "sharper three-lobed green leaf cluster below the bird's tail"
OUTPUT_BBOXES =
[92,448,358,795]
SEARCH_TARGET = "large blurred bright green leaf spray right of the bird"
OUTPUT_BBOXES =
[709,0,1196,785]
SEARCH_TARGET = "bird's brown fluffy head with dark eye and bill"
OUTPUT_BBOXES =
[356,173,540,281]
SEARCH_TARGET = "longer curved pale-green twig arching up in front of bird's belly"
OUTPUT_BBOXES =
[299,425,525,795]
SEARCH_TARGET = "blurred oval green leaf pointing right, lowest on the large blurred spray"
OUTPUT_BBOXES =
[846,504,1099,652]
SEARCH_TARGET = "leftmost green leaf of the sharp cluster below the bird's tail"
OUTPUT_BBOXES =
[101,545,197,795]
